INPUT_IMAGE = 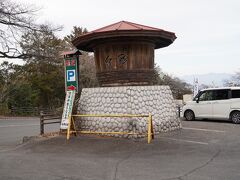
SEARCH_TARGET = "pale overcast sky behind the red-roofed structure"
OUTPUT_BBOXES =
[19,0,240,76]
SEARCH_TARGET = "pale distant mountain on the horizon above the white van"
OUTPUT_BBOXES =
[179,73,233,87]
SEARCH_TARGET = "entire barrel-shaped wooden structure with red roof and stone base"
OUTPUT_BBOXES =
[73,21,181,137]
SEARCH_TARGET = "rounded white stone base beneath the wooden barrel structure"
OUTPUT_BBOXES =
[77,86,181,137]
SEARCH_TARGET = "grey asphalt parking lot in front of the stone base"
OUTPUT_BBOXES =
[0,121,240,180]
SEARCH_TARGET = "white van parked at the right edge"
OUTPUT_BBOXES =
[182,87,240,123]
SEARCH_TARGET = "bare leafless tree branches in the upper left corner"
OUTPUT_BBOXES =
[0,0,62,59]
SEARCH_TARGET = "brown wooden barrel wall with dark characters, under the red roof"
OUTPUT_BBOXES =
[94,42,154,86]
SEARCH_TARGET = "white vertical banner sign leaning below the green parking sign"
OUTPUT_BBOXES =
[60,91,76,129]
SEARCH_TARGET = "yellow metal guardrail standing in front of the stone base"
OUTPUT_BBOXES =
[67,113,154,143]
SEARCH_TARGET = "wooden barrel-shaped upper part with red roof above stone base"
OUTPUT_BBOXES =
[72,21,176,86]
